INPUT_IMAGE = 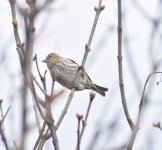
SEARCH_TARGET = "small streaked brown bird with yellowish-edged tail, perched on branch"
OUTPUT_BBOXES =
[42,53,108,96]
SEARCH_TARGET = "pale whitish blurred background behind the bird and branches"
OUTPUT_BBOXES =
[0,0,162,150]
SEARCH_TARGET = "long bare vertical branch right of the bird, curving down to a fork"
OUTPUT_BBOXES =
[118,0,134,129]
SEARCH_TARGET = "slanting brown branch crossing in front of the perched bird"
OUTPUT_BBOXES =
[56,0,105,129]
